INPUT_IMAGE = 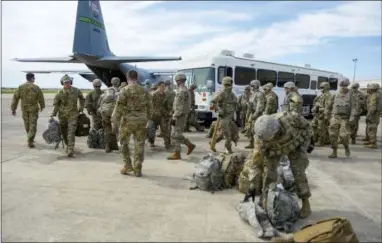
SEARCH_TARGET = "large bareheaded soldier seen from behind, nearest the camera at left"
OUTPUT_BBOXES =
[111,70,152,177]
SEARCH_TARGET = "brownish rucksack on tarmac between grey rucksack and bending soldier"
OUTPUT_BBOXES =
[218,152,246,188]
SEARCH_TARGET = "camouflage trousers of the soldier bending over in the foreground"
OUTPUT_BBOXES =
[247,149,311,199]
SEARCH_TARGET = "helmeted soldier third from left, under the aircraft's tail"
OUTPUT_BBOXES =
[85,79,103,130]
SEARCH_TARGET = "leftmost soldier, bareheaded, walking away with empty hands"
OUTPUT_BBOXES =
[11,73,45,148]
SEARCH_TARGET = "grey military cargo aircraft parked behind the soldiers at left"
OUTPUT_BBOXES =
[14,0,182,87]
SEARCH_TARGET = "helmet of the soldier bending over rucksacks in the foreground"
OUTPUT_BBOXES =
[254,115,280,141]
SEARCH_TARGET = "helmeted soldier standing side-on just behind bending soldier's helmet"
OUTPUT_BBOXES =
[245,80,265,149]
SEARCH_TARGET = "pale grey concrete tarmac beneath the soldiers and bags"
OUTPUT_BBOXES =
[1,95,382,242]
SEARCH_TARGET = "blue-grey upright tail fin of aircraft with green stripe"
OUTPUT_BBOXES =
[73,0,112,57]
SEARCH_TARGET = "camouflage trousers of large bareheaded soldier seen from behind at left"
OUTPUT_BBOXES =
[119,121,147,171]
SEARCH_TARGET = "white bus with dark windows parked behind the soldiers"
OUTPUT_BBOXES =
[179,50,343,126]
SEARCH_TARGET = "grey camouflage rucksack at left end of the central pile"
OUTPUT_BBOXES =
[190,154,224,193]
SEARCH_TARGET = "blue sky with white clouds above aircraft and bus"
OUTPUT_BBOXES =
[1,1,382,88]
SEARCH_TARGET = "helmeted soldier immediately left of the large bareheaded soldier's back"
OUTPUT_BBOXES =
[98,78,120,153]
